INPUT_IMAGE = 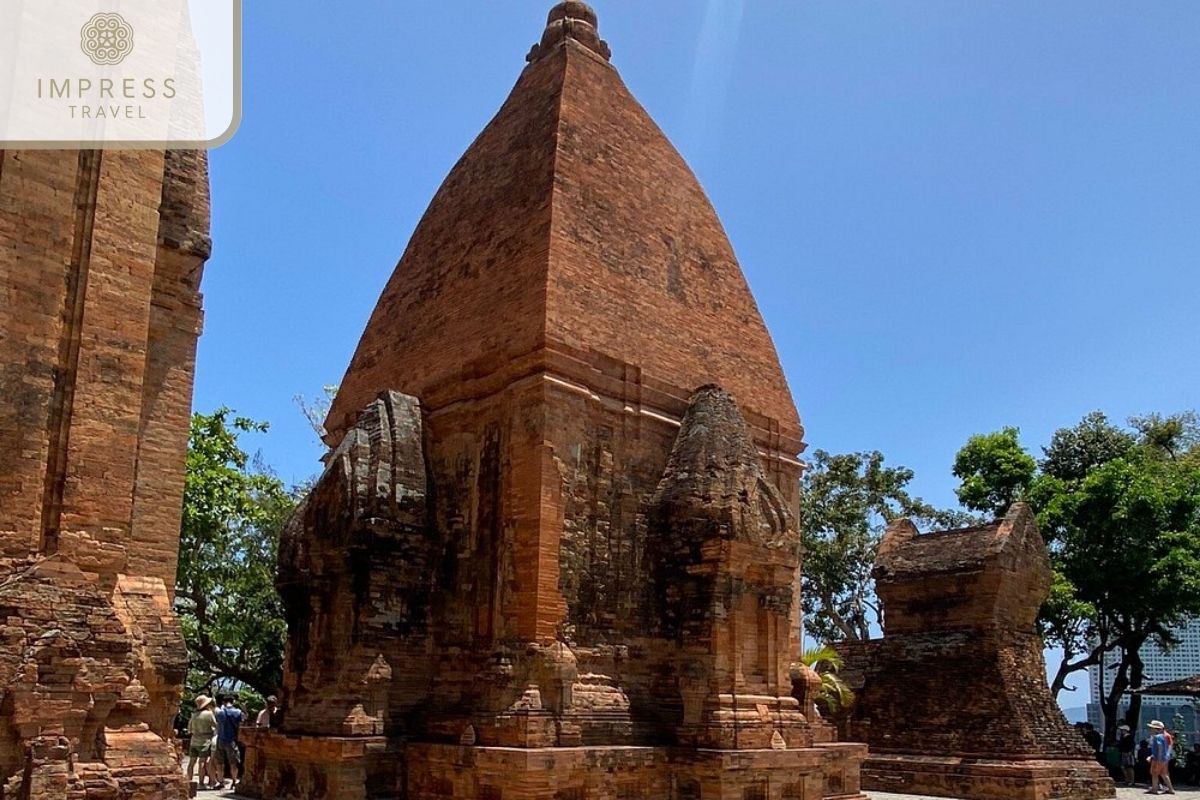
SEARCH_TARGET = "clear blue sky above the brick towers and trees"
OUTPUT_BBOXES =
[196,0,1200,704]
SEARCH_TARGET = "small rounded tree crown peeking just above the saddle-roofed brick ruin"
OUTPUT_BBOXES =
[954,428,1038,518]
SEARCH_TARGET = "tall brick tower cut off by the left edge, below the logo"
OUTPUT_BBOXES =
[0,150,210,800]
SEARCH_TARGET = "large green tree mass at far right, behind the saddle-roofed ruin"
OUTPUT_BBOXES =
[955,413,1200,739]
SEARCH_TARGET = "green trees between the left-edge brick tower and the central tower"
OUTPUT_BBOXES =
[175,409,295,697]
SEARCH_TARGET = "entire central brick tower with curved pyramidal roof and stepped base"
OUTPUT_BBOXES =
[242,2,865,800]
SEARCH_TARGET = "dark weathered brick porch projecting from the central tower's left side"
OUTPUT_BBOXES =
[278,392,437,735]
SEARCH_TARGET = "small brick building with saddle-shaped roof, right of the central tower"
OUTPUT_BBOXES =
[840,504,1115,800]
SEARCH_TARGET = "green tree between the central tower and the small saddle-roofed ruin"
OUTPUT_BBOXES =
[800,450,970,642]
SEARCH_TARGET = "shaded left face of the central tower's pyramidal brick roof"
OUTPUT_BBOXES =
[325,46,559,444]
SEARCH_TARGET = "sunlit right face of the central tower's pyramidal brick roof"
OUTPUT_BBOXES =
[549,48,800,441]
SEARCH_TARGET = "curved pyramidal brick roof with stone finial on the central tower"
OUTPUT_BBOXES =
[326,0,803,453]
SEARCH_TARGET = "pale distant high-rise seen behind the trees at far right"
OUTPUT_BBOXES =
[1087,619,1200,745]
